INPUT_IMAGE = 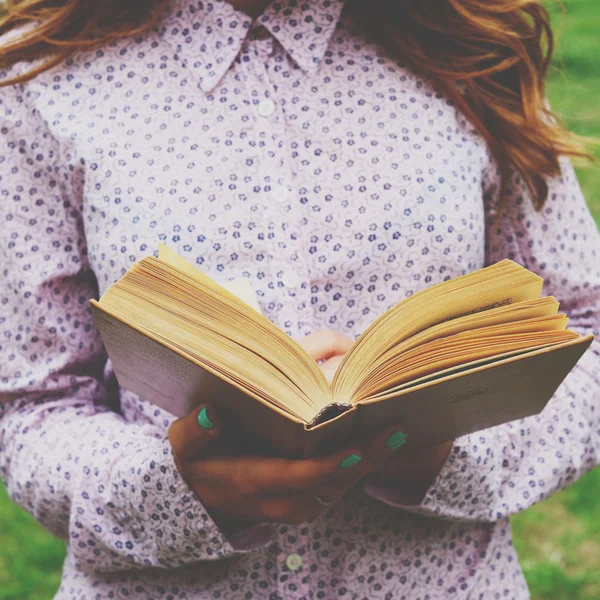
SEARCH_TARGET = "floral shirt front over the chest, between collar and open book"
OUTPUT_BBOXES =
[32,30,487,333]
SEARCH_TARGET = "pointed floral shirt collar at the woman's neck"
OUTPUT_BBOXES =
[161,0,344,92]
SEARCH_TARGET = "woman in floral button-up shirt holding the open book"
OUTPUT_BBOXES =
[0,0,600,600]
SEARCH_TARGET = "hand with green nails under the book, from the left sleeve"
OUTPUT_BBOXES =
[169,405,404,529]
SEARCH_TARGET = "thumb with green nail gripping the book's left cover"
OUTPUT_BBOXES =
[169,404,221,462]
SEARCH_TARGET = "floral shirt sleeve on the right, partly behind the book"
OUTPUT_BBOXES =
[365,155,600,521]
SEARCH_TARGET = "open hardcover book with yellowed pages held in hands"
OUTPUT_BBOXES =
[91,247,593,456]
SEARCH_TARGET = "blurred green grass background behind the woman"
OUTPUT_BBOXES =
[0,0,600,600]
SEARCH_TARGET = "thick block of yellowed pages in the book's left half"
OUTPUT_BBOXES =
[100,257,331,420]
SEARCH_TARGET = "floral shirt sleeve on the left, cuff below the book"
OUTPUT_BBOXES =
[0,74,272,571]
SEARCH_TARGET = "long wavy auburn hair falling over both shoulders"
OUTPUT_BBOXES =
[0,0,591,209]
